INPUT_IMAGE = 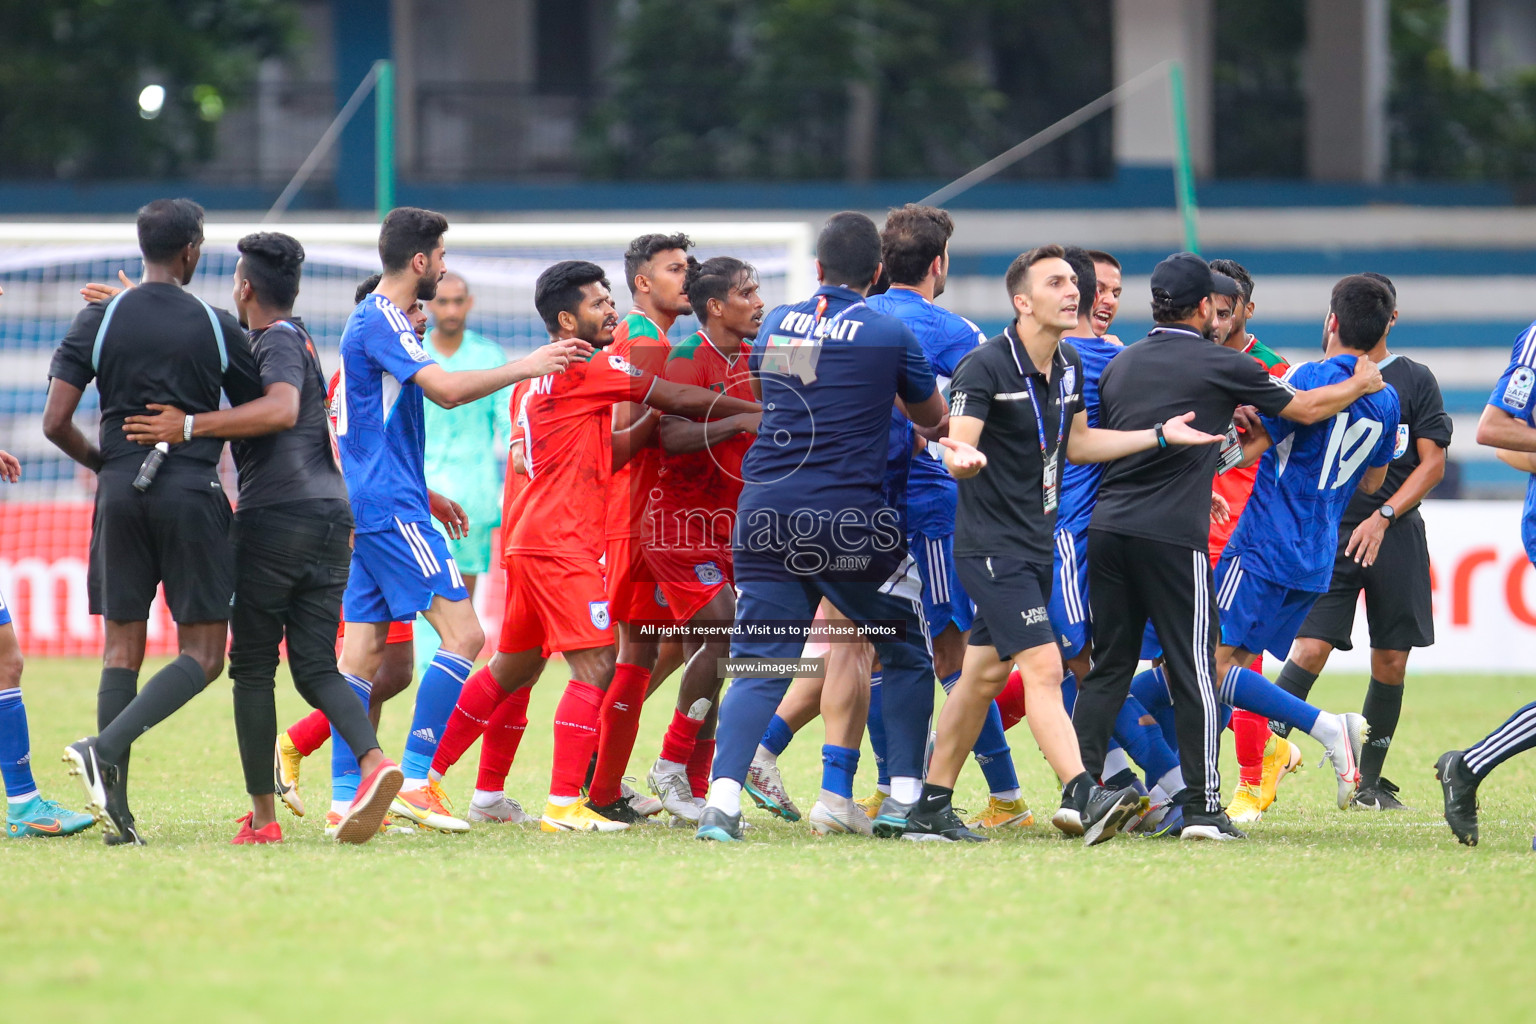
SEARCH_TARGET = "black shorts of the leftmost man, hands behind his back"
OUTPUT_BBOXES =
[88,465,235,623]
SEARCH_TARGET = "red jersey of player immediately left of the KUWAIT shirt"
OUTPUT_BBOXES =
[647,330,756,547]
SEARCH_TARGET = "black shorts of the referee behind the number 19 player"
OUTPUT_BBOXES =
[1296,510,1435,651]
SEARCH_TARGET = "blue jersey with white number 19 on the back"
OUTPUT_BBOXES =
[1227,355,1399,594]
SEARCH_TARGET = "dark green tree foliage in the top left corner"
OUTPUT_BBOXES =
[0,0,298,178]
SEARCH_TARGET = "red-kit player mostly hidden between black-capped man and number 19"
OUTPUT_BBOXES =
[1210,259,1301,823]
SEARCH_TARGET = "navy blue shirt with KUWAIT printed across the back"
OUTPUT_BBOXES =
[737,286,934,519]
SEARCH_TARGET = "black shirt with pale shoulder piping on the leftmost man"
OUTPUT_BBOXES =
[48,284,261,467]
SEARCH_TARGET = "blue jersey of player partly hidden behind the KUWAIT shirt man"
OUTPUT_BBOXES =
[869,289,986,537]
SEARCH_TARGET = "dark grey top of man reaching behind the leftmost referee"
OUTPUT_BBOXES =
[230,319,347,508]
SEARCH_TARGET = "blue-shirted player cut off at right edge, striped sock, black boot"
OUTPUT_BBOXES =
[1435,316,1536,846]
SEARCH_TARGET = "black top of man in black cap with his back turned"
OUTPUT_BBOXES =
[1089,325,1295,551]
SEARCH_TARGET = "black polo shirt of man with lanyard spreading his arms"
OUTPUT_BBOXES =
[949,327,1083,565]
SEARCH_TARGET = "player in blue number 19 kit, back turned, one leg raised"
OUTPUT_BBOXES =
[1215,275,1399,808]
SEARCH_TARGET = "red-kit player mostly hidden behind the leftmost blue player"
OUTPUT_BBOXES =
[272,273,468,820]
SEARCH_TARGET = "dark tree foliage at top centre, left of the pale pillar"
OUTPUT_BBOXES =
[587,0,1109,178]
